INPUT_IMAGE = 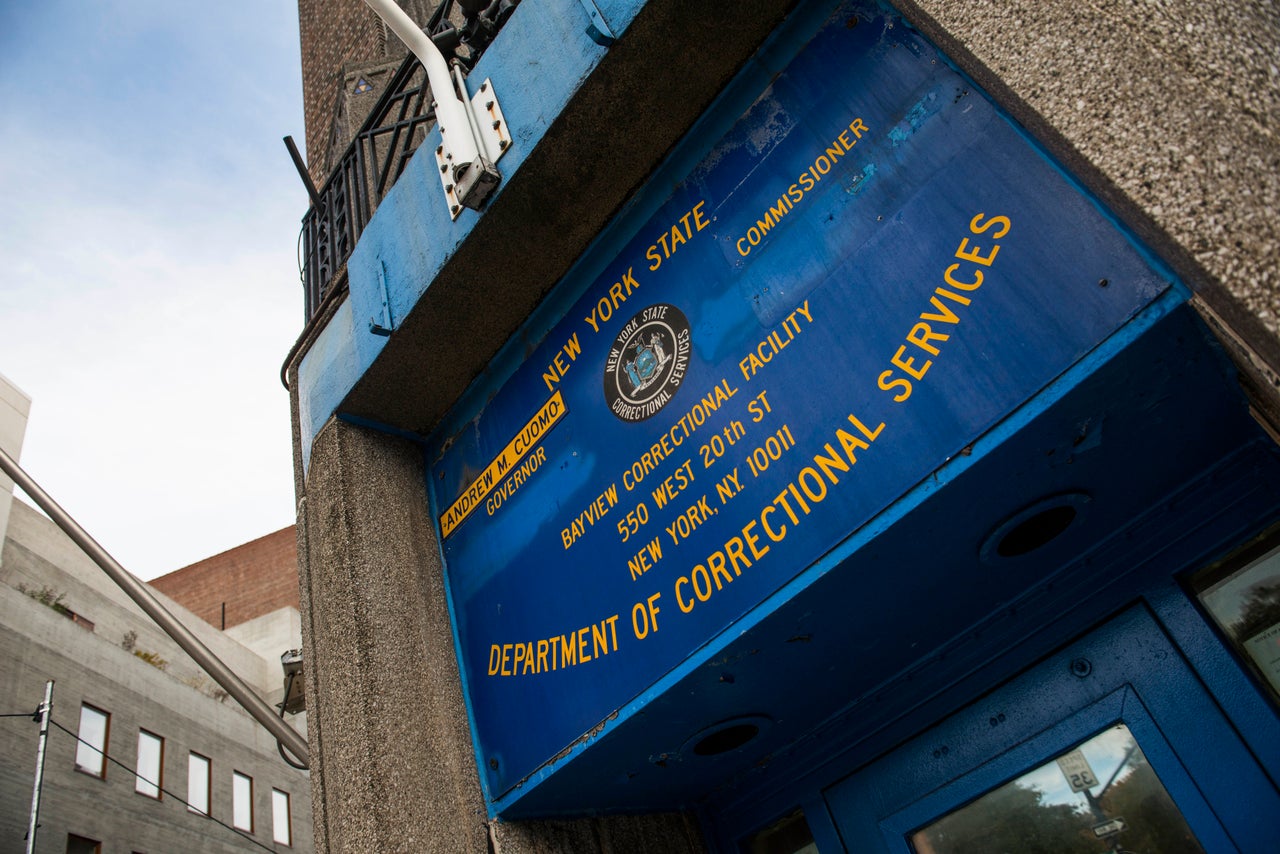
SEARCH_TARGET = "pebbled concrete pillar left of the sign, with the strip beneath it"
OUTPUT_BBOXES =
[300,421,704,854]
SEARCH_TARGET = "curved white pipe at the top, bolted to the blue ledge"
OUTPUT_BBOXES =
[365,0,499,210]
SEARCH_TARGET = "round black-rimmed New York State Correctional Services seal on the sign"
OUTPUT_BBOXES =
[604,302,690,421]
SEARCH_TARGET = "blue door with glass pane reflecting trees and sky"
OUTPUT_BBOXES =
[823,607,1280,854]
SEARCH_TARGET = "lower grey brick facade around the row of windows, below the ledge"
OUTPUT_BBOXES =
[0,585,312,854]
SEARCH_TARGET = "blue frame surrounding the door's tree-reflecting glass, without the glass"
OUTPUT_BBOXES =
[810,604,1280,853]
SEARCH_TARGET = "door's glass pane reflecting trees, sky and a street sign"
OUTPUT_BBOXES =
[911,723,1203,854]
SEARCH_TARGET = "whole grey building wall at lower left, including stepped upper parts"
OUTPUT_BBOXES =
[0,502,312,854]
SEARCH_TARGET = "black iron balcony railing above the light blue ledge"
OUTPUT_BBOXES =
[300,0,520,323]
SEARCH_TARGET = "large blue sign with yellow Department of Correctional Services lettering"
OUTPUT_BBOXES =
[430,3,1169,796]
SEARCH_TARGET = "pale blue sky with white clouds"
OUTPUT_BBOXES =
[0,0,307,579]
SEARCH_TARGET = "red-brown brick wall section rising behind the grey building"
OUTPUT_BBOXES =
[151,525,298,629]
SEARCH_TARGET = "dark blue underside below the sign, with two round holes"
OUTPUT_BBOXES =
[494,297,1280,819]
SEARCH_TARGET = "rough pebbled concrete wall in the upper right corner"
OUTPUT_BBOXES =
[897,0,1280,423]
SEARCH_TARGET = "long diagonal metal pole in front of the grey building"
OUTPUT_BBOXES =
[0,448,311,764]
